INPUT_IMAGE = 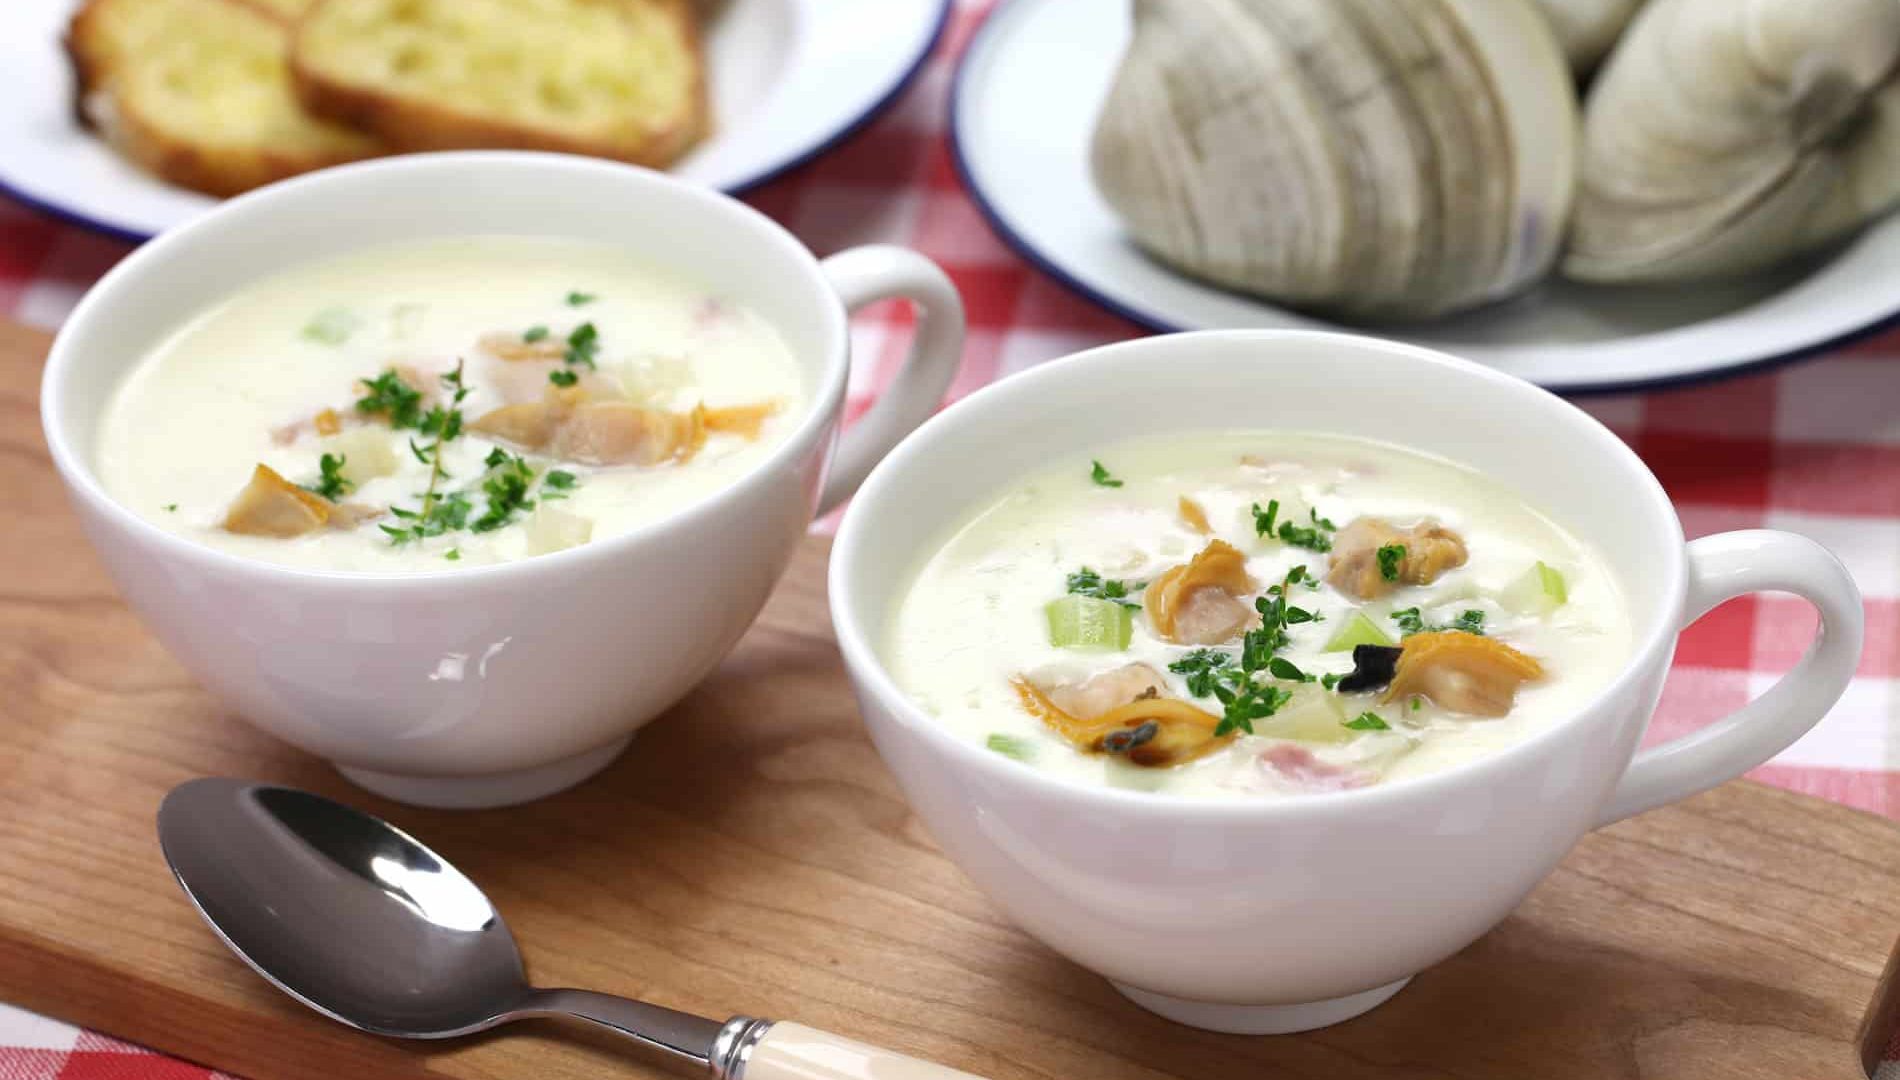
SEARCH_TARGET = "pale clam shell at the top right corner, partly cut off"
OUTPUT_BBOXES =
[1564,0,1900,281]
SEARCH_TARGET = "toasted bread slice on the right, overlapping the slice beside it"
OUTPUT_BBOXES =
[291,0,707,165]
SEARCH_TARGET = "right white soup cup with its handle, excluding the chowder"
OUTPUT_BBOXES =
[830,331,1862,1034]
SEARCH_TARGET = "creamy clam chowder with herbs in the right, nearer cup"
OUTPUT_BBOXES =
[885,434,1630,799]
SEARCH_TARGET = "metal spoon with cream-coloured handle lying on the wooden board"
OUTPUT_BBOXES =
[158,780,980,1080]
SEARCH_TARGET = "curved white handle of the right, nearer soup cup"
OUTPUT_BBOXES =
[1598,529,1866,827]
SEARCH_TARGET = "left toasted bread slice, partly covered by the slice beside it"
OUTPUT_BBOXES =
[67,0,380,196]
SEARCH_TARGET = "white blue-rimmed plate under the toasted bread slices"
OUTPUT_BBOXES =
[0,0,952,241]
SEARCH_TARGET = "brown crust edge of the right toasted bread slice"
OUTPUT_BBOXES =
[291,0,711,169]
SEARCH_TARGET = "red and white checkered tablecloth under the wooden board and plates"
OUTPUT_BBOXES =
[0,0,1900,1080]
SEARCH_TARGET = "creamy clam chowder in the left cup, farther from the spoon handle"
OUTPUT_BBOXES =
[97,238,804,572]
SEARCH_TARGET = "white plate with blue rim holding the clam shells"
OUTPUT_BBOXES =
[950,0,1900,394]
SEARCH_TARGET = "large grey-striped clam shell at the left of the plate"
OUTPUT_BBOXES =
[1091,0,1577,318]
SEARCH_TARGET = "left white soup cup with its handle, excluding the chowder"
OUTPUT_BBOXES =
[40,152,963,806]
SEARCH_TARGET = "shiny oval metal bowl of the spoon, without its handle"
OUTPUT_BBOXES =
[158,780,528,1038]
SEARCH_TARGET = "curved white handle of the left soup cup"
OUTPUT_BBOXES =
[819,243,963,513]
